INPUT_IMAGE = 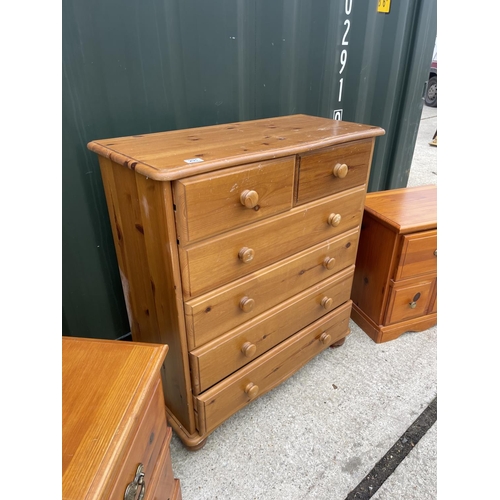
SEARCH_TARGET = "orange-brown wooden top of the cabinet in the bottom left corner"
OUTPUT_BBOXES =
[62,337,168,499]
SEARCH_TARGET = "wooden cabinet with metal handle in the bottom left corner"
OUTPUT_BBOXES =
[62,337,181,500]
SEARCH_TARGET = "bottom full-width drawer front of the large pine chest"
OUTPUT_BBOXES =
[195,301,352,433]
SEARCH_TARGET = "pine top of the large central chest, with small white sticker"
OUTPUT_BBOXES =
[87,115,385,181]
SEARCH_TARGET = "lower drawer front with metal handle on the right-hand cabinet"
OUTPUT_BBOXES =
[384,277,435,325]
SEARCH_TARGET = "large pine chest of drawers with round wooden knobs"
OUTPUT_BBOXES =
[88,115,384,449]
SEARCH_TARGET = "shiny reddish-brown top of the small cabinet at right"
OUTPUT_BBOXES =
[365,184,437,234]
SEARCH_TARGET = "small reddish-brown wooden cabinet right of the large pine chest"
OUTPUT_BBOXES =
[351,185,437,343]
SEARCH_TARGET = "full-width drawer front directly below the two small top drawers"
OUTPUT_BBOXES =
[179,187,365,298]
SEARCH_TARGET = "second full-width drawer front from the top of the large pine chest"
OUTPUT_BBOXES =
[184,229,359,348]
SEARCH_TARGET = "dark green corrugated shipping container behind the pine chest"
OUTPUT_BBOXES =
[62,0,437,339]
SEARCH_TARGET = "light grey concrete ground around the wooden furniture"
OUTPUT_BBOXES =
[171,106,437,500]
